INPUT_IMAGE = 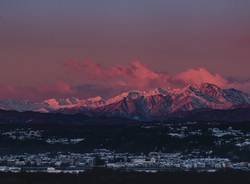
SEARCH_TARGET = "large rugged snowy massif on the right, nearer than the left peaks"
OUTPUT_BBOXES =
[93,83,250,118]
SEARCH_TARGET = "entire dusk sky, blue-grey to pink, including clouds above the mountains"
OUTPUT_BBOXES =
[0,0,250,100]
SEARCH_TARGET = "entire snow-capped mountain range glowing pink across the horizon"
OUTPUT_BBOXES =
[0,83,250,120]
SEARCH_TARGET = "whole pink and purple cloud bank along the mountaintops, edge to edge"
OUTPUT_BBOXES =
[0,60,250,100]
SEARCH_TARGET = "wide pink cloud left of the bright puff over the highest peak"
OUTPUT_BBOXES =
[65,61,169,89]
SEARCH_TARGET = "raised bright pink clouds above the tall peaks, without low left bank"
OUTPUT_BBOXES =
[65,61,250,94]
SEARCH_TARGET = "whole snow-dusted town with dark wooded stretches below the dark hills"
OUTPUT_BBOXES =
[0,122,250,173]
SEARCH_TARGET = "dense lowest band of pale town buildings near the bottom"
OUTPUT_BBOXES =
[0,149,250,174]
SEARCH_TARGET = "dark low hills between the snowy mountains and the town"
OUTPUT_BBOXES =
[0,107,250,124]
